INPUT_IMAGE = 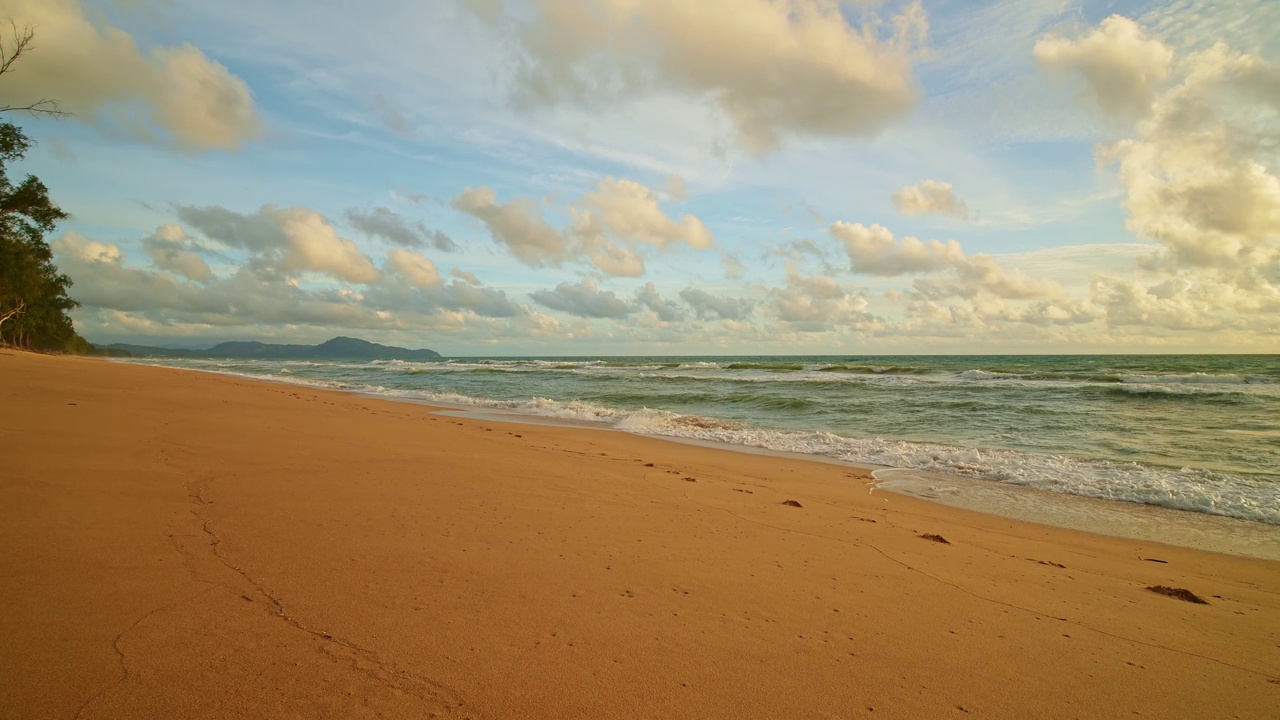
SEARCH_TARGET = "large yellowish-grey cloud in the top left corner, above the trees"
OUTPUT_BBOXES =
[0,0,261,151]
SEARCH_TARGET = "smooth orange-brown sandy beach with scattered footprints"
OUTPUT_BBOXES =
[0,351,1280,720]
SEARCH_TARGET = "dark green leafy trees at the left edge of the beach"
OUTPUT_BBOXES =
[0,123,88,352]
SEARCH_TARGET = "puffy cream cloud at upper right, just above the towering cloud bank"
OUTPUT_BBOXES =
[1034,15,1174,117]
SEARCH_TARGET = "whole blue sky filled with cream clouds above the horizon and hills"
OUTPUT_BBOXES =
[0,0,1280,356]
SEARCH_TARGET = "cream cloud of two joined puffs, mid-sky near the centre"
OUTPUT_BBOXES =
[452,177,716,277]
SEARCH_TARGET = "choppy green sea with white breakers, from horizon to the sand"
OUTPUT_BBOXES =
[127,355,1280,559]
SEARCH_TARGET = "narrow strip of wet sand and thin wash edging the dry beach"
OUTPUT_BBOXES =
[115,356,1280,560]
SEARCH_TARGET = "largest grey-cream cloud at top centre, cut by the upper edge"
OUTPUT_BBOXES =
[494,0,928,154]
